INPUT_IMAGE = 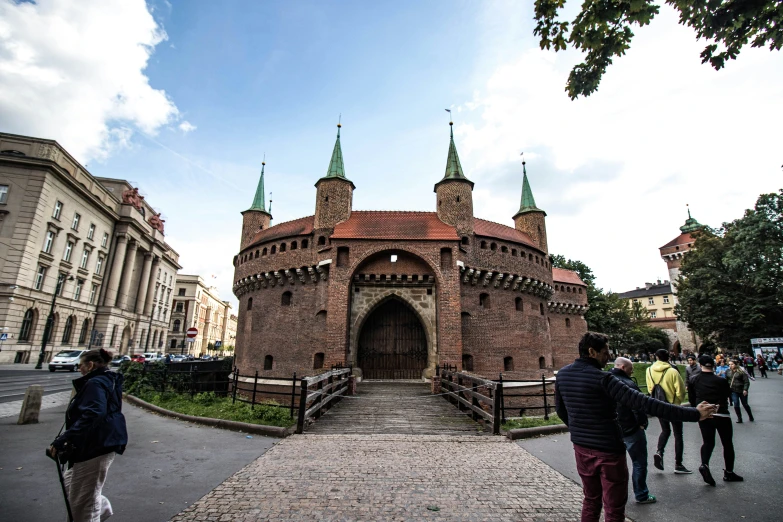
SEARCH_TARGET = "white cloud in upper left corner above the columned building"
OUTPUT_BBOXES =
[0,0,178,162]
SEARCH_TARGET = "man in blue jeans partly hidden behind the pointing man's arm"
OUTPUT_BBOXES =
[612,357,656,504]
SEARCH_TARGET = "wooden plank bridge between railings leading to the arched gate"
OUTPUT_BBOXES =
[305,381,485,435]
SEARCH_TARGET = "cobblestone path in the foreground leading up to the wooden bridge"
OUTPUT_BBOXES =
[171,434,582,522]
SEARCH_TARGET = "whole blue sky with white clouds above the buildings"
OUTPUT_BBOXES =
[0,0,783,303]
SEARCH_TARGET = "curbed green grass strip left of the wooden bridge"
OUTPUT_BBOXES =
[138,392,296,428]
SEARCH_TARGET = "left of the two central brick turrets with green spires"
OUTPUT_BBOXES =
[313,123,356,229]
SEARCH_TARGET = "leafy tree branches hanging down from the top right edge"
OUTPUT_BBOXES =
[534,0,783,100]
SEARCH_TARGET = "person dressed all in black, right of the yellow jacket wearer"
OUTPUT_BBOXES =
[688,355,744,487]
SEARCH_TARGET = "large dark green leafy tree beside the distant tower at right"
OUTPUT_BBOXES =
[675,190,783,351]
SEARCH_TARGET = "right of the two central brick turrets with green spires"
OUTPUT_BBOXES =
[435,121,473,236]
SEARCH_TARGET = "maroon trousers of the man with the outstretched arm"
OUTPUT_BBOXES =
[574,444,628,522]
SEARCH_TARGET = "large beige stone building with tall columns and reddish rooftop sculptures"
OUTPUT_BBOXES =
[0,133,180,363]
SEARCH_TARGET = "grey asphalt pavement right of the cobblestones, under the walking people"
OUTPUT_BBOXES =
[519,373,783,522]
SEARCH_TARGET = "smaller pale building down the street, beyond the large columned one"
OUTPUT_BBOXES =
[166,274,236,356]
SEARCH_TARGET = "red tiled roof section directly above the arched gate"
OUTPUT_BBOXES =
[332,210,459,241]
